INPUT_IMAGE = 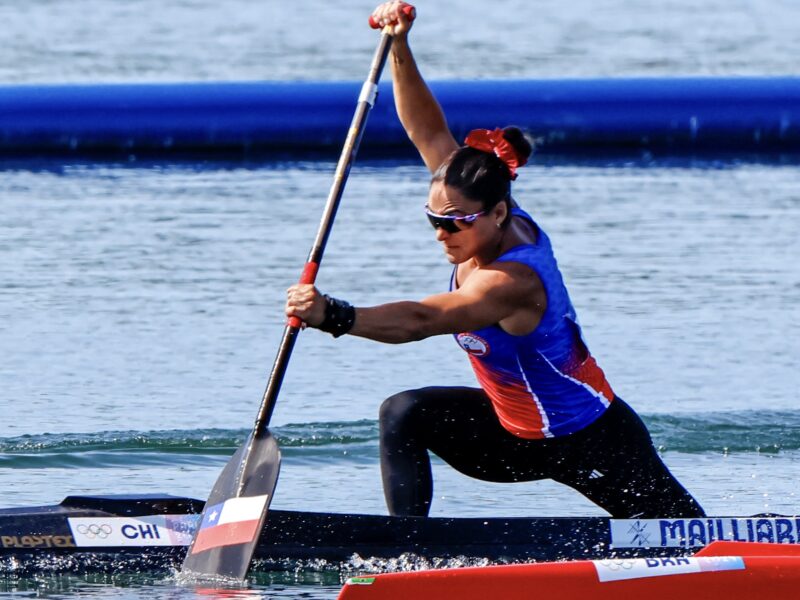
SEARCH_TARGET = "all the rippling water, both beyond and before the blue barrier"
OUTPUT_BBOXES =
[0,0,800,599]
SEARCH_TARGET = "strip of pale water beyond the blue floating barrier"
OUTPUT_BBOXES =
[0,0,800,82]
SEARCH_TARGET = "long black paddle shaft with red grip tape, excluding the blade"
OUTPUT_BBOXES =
[244,31,392,454]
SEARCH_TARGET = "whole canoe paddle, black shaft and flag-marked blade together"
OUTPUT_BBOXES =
[181,6,414,582]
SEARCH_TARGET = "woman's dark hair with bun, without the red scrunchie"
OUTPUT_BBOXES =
[431,127,533,210]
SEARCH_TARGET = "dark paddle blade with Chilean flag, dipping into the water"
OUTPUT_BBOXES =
[181,430,281,582]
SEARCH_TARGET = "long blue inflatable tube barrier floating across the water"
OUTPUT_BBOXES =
[0,77,800,157]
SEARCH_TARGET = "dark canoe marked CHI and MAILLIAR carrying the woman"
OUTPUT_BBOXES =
[0,494,800,573]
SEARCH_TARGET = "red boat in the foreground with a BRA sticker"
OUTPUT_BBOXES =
[339,542,800,600]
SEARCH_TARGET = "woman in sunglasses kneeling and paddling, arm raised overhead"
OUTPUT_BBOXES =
[286,2,703,518]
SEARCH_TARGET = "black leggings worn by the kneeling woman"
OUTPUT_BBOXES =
[380,387,704,518]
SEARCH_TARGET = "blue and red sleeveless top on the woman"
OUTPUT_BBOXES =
[450,208,614,439]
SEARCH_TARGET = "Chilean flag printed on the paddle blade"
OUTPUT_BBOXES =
[192,494,268,554]
